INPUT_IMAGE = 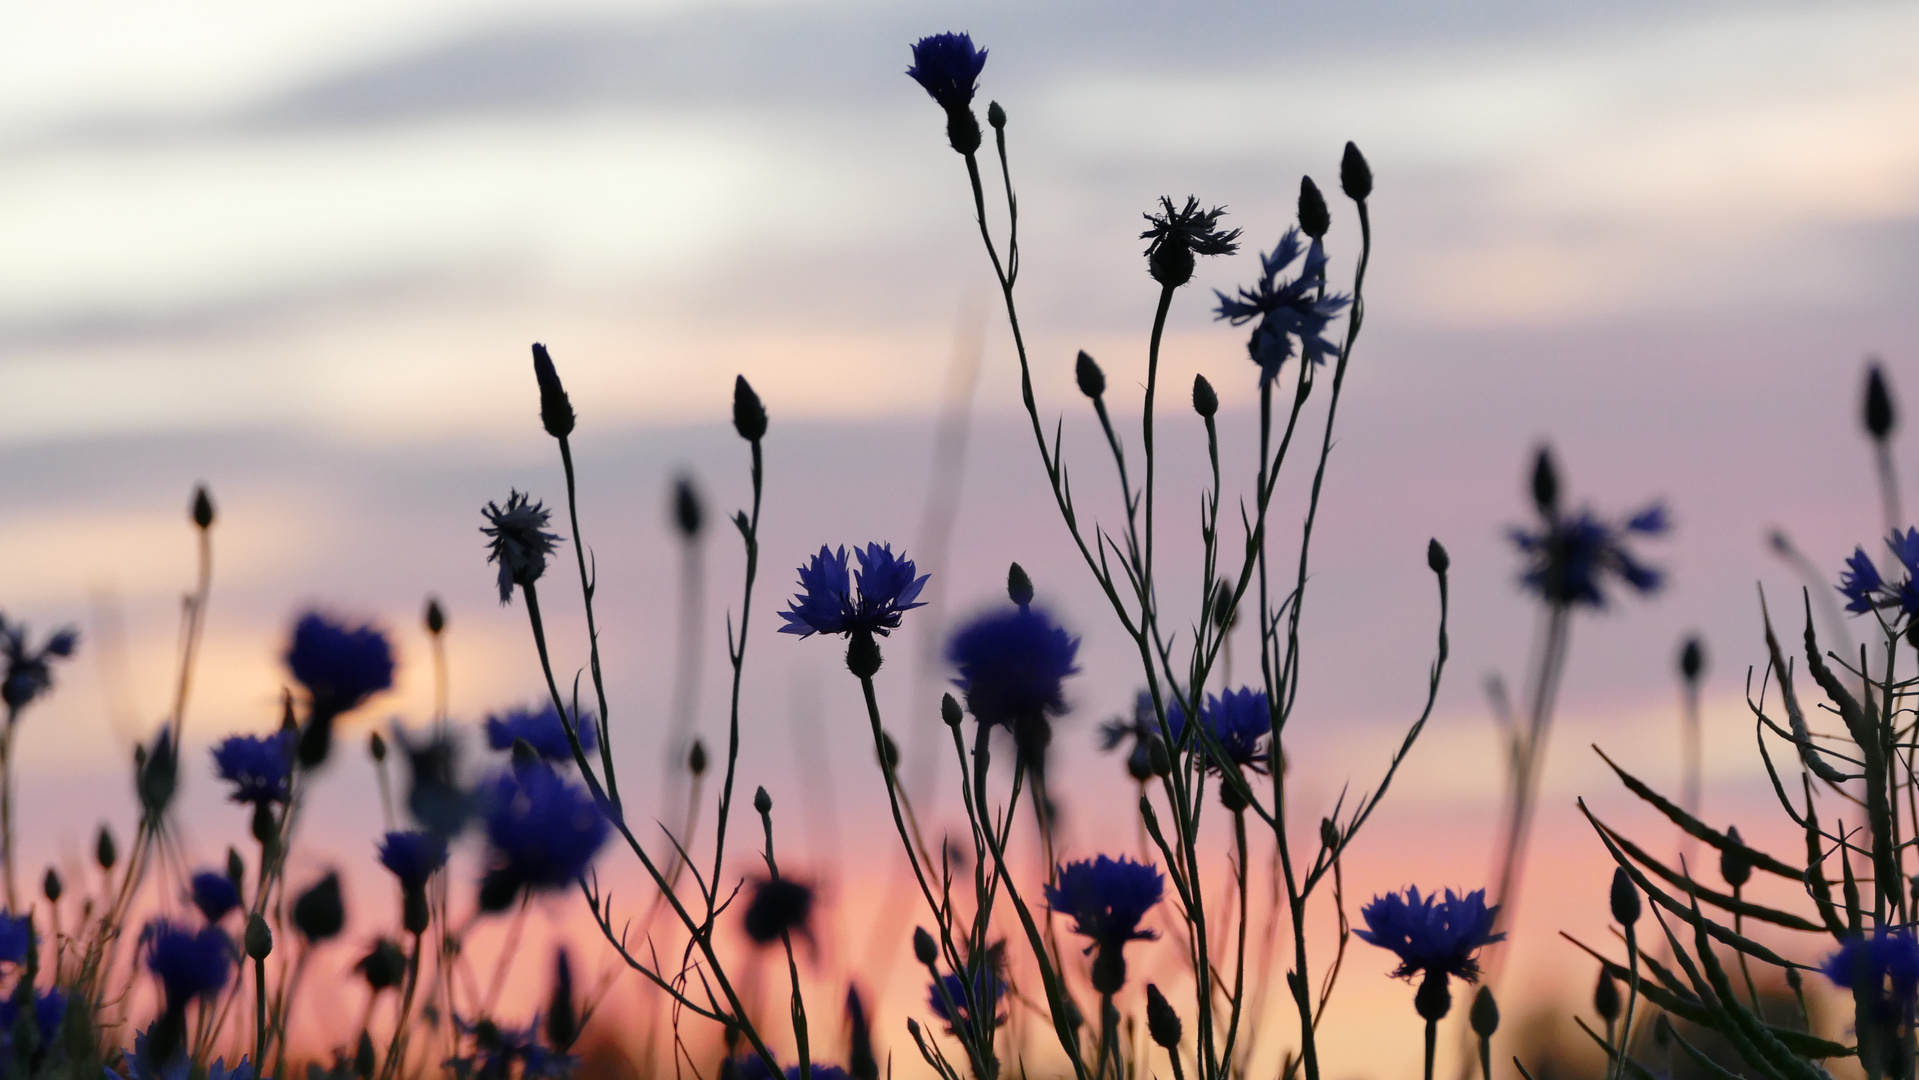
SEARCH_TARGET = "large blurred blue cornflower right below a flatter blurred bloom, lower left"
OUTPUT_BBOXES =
[482,760,610,900]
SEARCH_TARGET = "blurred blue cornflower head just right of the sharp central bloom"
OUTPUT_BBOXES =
[946,604,1078,727]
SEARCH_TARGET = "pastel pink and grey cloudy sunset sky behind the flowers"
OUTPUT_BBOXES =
[0,0,1919,1080]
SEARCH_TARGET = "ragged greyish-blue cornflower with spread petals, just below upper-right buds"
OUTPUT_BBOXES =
[1213,228,1353,384]
